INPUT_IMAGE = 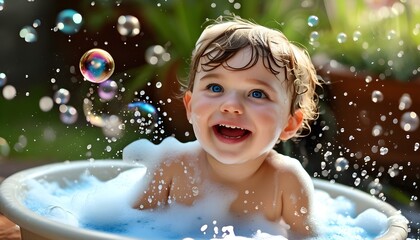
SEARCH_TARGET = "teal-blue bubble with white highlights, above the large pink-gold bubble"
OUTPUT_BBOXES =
[56,9,83,34]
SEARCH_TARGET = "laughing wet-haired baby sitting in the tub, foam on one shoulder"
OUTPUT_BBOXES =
[123,17,319,238]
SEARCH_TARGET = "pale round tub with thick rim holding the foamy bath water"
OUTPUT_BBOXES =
[0,160,408,240]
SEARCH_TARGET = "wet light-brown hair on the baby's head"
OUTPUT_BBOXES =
[181,16,320,136]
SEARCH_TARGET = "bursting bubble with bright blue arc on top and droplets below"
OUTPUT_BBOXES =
[128,102,158,134]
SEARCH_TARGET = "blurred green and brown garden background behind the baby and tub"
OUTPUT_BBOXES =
[0,0,420,238]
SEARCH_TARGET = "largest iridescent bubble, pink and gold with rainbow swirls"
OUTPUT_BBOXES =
[79,48,115,83]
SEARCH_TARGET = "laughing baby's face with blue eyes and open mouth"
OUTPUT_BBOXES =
[184,49,292,164]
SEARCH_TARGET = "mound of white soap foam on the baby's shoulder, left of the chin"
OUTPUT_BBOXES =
[122,137,200,166]
